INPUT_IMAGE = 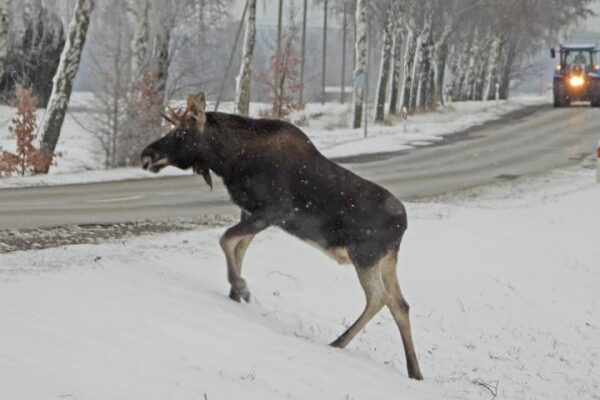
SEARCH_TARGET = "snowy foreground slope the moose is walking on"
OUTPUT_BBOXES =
[0,164,600,400]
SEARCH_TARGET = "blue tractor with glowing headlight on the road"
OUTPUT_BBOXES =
[550,45,600,107]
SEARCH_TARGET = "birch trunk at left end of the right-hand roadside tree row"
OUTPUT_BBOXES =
[352,0,368,128]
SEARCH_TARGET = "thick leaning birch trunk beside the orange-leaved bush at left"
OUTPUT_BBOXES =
[40,0,94,173]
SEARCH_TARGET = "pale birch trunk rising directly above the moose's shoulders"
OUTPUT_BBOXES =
[234,0,256,115]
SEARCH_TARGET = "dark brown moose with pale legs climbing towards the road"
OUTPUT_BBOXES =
[141,93,423,380]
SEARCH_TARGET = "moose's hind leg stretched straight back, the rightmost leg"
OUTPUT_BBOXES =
[382,251,423,380]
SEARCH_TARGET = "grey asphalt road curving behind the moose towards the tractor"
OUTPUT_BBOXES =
[0,106,600,228]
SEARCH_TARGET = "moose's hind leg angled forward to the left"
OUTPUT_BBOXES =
[331,263,387,348]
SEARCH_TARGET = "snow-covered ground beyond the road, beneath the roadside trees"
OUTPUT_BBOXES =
[0,93,549,189]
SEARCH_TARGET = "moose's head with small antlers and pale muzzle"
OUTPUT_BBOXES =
[141,93,212,188]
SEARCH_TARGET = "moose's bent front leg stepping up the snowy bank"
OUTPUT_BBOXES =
[220,213,269,302]
